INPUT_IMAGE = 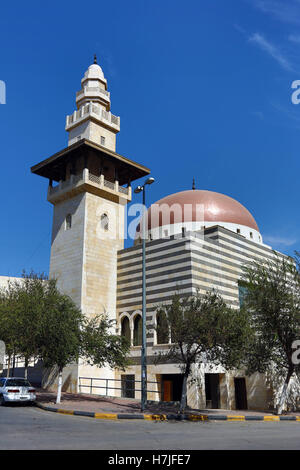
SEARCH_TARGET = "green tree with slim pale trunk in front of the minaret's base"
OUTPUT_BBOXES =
[40,280,130,403]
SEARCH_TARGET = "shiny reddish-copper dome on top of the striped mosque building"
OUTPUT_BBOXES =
[144,190,259,232]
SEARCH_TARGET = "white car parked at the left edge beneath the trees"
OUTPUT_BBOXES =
[0,377,36,405]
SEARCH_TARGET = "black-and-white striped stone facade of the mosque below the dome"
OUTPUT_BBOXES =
[117,215,274,409]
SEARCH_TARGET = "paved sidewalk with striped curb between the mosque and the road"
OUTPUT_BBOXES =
[37,390,300,420]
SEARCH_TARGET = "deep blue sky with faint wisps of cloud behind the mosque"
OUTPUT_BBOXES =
[0,0,300,275]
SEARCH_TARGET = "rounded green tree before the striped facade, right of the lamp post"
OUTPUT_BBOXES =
[157,291,251,412]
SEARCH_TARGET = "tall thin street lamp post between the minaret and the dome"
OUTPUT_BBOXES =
[134,178,154,411]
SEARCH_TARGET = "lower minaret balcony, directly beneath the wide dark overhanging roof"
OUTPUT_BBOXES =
[47,168,131,204]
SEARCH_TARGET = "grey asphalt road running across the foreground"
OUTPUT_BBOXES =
[0,406,300,450]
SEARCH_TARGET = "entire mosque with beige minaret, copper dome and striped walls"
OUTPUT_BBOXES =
[0,57,288,409]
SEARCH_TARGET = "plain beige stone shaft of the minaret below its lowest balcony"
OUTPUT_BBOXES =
[50,192,126,389]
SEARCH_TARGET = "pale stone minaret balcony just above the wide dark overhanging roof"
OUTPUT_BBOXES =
[66,103,120,132]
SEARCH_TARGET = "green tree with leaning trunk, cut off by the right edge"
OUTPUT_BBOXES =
[242,252,300,414]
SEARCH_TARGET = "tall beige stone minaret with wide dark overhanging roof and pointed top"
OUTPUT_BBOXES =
[31,58,150,391]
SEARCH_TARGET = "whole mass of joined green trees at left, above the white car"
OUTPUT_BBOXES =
[0,272,129,402]
